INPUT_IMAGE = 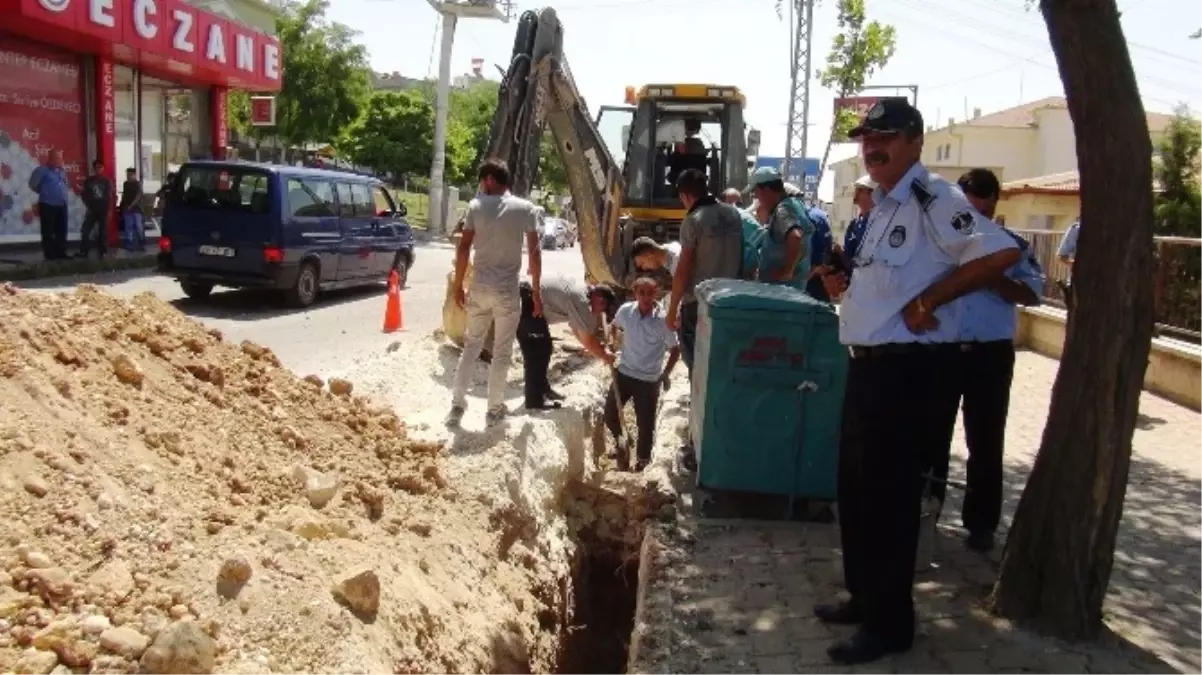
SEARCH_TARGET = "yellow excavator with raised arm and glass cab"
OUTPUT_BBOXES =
[442,8,760,347]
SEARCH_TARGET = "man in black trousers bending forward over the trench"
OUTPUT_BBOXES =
[518,275,618,410]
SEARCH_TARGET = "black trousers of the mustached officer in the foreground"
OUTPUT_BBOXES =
[838,346,957,639]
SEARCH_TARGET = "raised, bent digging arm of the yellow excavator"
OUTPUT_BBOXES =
[486,7,629,285]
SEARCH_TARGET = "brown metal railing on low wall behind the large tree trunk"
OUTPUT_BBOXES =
[1014,229,1202,344]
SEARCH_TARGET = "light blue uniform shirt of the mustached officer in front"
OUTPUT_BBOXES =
[839,163,1017,346]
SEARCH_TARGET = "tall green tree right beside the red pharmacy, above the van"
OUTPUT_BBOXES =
[228,0,371,147]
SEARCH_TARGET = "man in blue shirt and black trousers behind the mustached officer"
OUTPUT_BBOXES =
[933,168,1043,552]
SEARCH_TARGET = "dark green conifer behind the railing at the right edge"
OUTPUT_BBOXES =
[1154,106,1202,237]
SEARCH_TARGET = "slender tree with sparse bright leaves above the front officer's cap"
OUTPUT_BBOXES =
[817,0,897,175]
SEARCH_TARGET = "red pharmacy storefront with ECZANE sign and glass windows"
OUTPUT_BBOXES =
[0,0,282,244]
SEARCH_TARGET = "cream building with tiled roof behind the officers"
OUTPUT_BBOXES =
[831,96,1172,236]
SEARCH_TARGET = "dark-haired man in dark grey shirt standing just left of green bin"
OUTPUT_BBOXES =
[667,164,743,376]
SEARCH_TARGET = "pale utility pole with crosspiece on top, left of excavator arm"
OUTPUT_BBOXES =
[426,0,513,233]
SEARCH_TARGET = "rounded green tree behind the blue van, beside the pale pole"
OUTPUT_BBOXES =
[341,91,434,181]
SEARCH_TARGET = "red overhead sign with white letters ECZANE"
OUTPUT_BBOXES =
[0,0,282,91]
